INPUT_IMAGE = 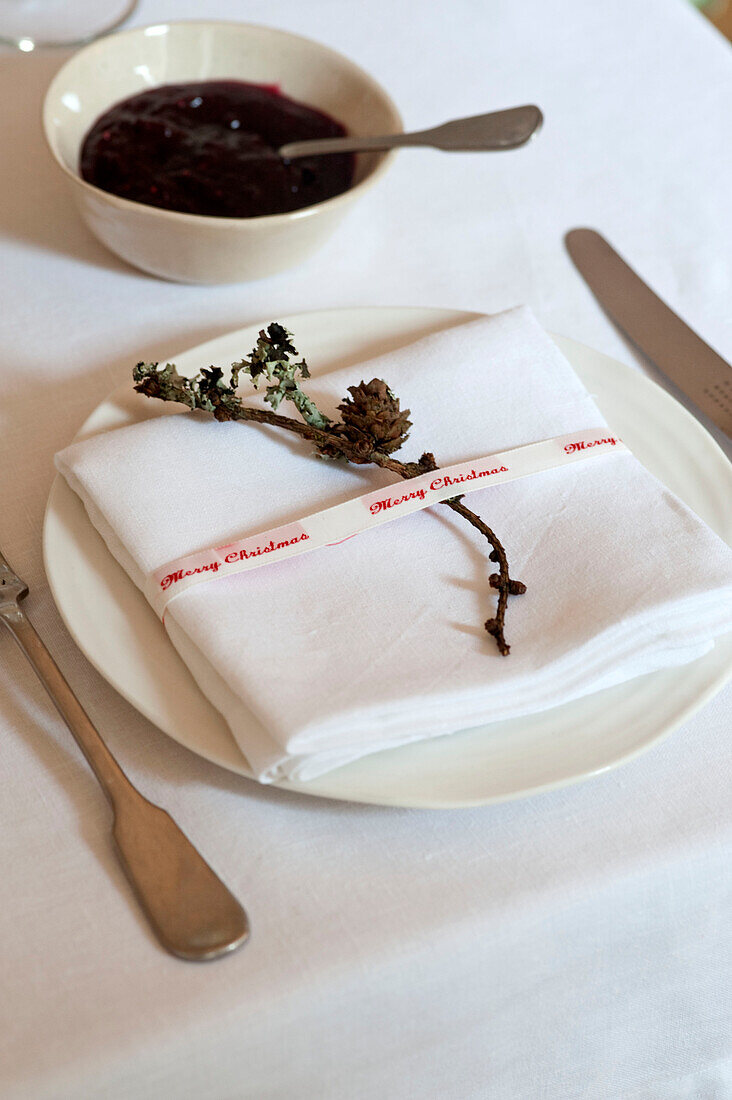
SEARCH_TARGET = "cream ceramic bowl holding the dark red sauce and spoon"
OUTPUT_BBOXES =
[43,21,402,283]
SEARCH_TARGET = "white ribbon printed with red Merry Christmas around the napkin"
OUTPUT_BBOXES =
[145,428,627,618]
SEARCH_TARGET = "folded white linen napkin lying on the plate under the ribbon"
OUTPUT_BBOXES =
[56,308,732,782]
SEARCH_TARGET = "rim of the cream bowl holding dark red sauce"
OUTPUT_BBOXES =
[41,19,404,230]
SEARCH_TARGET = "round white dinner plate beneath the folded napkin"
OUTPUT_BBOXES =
[44,308,732,807]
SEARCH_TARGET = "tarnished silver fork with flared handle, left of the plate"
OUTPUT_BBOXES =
[0,552,249,960]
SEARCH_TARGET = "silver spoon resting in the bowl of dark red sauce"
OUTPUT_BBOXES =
[280,107,544,161]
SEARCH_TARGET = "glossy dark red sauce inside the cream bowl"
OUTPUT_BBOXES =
[80,80,353,218]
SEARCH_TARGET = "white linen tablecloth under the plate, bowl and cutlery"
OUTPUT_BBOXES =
[0,0,732,1100]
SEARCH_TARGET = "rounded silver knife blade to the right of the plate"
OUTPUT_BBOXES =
[565,229,732,438]
